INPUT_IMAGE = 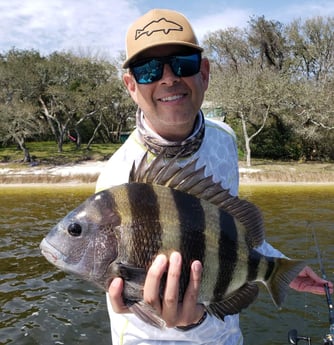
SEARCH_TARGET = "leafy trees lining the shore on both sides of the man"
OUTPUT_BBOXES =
[0,16,334,164]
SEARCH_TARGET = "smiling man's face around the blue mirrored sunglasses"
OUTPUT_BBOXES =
[123,45,209,140]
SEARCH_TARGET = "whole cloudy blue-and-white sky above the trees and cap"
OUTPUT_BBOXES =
[0,0,334,57]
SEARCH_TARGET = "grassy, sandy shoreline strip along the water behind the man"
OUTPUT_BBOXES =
[0,142,334,184]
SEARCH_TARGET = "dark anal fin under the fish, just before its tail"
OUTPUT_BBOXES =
[206,283,259,320]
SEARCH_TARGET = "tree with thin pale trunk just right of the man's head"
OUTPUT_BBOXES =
[205,17,287,166]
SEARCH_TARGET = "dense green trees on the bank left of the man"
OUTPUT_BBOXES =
[0,49,135,161]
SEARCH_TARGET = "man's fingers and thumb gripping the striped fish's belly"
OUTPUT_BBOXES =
[108,252,204,327]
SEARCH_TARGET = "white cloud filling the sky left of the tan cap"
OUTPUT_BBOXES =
[0,0,139,55]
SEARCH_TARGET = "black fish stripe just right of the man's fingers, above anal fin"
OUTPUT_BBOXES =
[213,210,238,301]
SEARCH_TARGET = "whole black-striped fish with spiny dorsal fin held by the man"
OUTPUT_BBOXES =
[40,155,305,328]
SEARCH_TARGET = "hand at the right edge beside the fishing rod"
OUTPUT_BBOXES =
[290,266,333,295]
